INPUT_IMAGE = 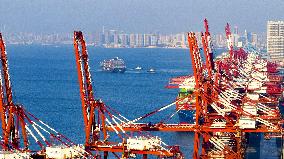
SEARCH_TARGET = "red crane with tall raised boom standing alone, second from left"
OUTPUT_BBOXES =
[74,31,183,159]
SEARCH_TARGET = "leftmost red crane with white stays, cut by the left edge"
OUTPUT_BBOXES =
[0,33,87,159]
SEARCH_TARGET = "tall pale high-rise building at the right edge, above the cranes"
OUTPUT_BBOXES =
[267,21,284,62]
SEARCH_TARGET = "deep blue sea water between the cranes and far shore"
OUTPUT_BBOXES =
[7,45,277,158]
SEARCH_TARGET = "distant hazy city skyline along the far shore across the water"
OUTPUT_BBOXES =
[1,26,266,50]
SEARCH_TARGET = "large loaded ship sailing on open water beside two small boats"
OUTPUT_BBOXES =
[100,57,126,73]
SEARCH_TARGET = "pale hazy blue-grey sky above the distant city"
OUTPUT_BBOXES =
[0,0,284,33]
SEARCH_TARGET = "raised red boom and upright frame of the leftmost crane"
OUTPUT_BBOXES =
[0,33,28,150]
